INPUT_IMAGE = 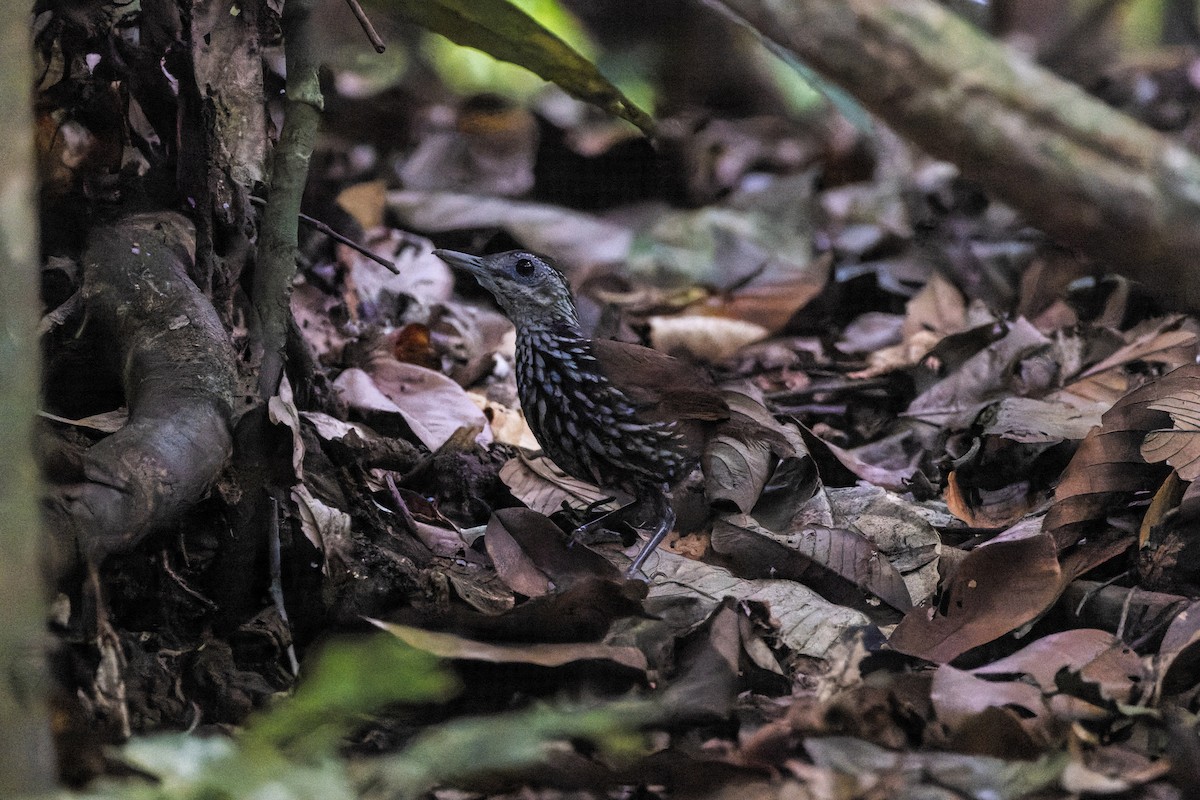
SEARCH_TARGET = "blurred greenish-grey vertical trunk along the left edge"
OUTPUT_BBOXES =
[0,2,54,798]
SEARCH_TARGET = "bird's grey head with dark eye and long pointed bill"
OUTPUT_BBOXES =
[433,249,578,327]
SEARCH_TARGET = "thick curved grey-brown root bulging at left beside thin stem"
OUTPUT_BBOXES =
[48,212,235,577]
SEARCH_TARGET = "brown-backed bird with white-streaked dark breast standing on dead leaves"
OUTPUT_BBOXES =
[433,249,730,578]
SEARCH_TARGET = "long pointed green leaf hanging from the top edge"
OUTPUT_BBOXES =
[377,0,654,134]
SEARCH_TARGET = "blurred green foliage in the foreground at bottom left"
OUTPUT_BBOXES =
[54,636,662,800]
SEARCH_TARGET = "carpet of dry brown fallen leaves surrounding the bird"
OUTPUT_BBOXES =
[39,7,1200,798]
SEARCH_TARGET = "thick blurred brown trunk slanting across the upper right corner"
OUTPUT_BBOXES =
[709,0,1200,311]
